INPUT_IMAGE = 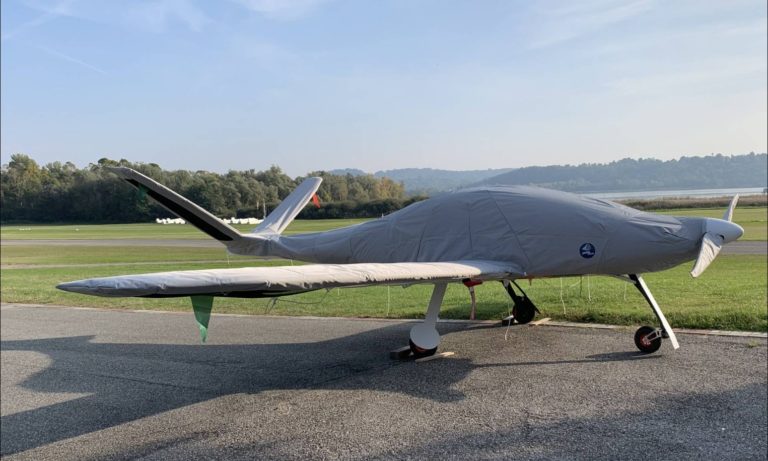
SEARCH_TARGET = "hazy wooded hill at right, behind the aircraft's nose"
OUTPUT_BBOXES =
[473,153,768,192]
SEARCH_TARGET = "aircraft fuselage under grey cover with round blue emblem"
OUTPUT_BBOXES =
[230,186,707,277]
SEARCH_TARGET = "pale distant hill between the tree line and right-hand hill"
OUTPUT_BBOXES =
[330,168,512,195]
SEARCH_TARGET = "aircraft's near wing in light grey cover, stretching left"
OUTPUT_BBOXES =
[57,261,524,298]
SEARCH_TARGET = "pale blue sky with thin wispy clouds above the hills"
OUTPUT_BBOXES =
[0,0,768,176]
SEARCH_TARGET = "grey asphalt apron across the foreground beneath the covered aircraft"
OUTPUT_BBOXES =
[0,305,768,461]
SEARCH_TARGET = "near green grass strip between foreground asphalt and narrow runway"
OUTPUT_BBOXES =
[0,246,768,331]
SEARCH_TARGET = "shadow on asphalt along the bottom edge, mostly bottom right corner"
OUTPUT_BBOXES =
[85,384,768,461]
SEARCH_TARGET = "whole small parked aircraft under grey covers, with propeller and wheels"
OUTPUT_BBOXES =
[58,167,744,356]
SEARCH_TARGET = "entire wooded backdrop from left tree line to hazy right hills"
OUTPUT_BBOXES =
[0,153,768,223]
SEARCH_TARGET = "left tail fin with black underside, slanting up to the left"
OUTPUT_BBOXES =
[108,167,243,244]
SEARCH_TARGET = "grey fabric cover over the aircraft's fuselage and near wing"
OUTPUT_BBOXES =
[59,187,704,296]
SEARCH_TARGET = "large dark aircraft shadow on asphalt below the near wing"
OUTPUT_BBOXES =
[0,323,656,456]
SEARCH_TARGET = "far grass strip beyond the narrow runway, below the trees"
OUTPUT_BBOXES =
[0,207,768,240]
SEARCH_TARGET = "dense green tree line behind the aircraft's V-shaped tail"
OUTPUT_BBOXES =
[0,154,415,223]
